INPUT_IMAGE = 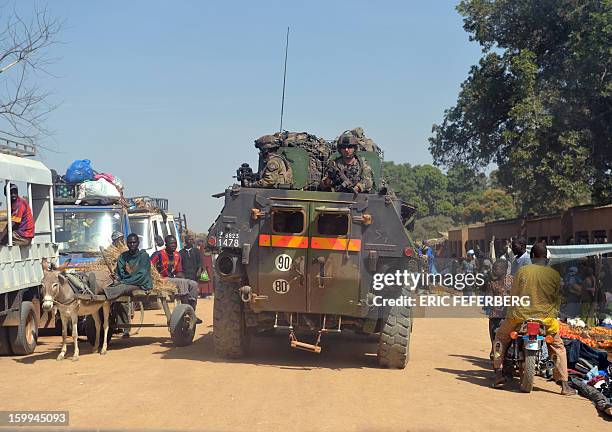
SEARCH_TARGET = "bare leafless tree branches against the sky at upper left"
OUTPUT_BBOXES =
[0,7,61,144]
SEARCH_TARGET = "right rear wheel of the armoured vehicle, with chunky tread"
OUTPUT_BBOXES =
[378,290,412,369]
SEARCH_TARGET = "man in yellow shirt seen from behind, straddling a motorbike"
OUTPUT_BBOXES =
[493,243,576,395]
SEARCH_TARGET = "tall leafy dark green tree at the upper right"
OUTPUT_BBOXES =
[429,0,612,214]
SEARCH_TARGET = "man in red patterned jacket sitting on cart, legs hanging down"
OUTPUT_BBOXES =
[151,235,202,324]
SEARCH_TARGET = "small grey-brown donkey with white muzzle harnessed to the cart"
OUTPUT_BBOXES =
[42,262,110,361]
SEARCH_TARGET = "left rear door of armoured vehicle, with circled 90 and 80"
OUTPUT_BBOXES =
[257,201,309,312]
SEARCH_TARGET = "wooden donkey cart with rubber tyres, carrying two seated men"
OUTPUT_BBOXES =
[84,288,196,347]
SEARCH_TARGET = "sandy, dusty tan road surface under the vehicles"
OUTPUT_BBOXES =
[0,300,610,432]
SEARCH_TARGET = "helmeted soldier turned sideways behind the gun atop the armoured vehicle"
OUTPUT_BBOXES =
[246,135,293,188]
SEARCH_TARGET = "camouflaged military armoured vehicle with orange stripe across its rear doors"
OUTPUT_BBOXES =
[207,132,420,368]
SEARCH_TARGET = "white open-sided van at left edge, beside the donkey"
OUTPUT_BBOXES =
[0,140,58,355]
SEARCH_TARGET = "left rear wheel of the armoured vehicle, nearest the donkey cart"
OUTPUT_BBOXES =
[213,280,250,358]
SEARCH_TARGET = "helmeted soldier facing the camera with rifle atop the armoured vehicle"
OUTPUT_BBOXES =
[321,135,373,193]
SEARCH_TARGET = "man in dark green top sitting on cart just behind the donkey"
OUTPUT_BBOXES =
[104,233,153,300]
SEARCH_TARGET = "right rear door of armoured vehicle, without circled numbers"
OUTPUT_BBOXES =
[307,204,361,315]
